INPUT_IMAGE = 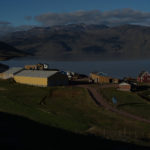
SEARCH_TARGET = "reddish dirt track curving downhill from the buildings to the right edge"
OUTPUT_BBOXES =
[78,85,150,123]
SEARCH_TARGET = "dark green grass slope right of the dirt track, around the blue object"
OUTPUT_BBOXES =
[100,88,150,120]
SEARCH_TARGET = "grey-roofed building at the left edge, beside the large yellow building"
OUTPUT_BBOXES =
[0,67,23,79]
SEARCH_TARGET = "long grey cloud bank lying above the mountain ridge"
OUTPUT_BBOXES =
[34,8,150,26]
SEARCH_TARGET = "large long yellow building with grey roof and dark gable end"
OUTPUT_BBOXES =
[14,70,69,87]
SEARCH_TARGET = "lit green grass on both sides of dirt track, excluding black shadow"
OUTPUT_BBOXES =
[0,80,150,146]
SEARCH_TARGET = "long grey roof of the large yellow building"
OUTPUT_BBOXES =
[16,70,58,78]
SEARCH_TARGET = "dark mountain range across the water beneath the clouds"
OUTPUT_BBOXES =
[0,24,150,60]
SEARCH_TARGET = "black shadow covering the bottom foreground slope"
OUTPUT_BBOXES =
[0,113,149,150]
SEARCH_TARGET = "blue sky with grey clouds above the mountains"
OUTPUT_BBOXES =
[0,0,150,34]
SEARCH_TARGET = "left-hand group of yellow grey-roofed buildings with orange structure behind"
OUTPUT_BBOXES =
[0,65,69,87]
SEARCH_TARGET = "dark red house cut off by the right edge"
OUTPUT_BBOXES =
[137,71,150,82]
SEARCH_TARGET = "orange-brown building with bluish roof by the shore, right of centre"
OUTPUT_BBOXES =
[90,72,111,84]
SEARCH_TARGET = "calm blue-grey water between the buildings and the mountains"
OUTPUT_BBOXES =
[1,58,150,78]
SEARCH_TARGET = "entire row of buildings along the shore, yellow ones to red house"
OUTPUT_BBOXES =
[0,64,150,91]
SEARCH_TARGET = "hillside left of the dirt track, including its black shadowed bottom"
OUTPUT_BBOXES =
[0,80,150,150]
